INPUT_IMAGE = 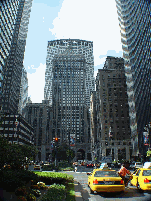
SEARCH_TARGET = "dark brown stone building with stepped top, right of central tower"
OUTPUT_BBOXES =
[96,57,131,161]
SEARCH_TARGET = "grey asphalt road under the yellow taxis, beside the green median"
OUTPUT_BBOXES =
[66,166,151,201]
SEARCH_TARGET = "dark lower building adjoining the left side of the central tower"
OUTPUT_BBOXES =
[24,101,53,161]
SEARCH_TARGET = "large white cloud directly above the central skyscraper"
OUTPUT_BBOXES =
[49,0,122,66]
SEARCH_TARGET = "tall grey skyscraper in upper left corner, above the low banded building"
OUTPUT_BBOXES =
[0,0,32,113]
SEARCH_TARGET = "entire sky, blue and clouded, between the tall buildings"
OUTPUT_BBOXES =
[24,0,122,103]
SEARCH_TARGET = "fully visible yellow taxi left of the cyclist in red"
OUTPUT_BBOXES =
[88,168,125,194]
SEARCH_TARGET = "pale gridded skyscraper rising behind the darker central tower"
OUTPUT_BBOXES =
[44,39,95,107]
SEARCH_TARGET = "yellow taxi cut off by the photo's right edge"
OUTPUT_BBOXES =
[130,168,151,191]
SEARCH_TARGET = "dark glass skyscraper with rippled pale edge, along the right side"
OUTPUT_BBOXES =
[116,0,151,156]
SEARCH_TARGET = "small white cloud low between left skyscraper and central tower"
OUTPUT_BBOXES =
[27,63,46,103]
